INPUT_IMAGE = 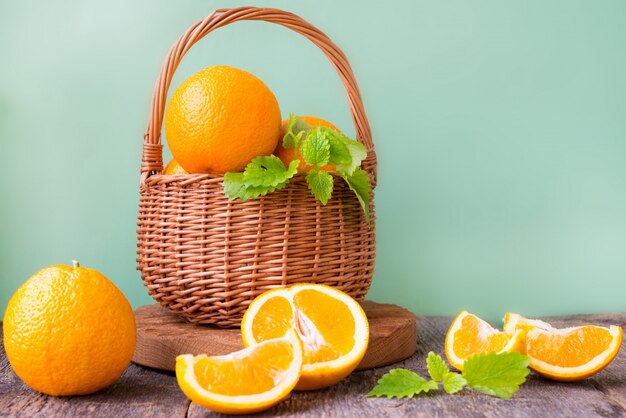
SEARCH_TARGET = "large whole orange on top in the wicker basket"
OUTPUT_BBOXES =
[165,65,280,173]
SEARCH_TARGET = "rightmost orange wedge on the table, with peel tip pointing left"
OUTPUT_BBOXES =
[505,314,623,381]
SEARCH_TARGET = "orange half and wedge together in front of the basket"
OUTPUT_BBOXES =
[176,284,369,414]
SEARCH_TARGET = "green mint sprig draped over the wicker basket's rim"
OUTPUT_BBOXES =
[224,114,372,224]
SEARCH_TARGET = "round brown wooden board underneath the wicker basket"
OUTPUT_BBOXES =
[133,301,417,370]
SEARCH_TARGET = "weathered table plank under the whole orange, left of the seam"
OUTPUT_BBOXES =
[0,330,190,418]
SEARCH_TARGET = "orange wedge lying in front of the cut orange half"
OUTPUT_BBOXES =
[176,332,302,414]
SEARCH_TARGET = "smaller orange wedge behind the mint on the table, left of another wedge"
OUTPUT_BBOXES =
[445,311,523,370]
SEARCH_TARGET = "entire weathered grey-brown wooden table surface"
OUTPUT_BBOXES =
[0,313,626,418]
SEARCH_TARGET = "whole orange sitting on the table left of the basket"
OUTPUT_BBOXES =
[3,263,135,396]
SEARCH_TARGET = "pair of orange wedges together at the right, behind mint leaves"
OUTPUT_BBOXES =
[445,311,622,381]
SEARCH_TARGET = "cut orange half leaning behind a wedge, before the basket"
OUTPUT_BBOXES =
[241,284,369,390]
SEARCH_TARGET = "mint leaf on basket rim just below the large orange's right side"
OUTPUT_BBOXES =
[243,155,300,187]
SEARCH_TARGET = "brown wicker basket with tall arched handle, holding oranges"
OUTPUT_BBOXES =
[137,7,376,327]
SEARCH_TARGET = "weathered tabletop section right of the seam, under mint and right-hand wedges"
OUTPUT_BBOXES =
[188,314,626,418]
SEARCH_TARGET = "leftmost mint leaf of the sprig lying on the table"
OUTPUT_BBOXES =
[367,369,437,398]
